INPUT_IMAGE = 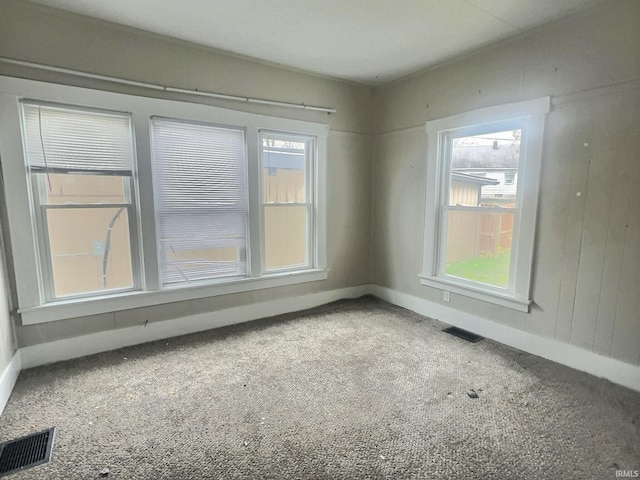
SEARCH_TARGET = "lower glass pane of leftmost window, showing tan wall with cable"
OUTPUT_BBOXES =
[45,207,133,297]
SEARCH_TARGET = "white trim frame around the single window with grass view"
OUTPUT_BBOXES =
[419,97,551,312]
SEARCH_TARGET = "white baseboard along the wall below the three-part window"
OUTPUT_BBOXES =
[20,285,371,368]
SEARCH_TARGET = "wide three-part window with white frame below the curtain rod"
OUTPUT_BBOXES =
[0,77,329,325]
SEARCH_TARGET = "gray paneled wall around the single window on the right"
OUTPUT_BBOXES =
[372,0,640,365]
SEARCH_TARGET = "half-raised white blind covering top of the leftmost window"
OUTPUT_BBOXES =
[23,103,133,175]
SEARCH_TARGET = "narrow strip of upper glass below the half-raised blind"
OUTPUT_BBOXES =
[38,174,129,205]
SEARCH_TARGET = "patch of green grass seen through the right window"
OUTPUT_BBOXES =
[444,250,511,288]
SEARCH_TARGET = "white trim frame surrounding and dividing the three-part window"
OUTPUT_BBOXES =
[0,76,329,325]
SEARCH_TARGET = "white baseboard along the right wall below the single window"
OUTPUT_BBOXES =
[369,285,640,392]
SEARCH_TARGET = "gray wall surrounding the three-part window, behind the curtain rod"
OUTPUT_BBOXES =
[0,0,373,347]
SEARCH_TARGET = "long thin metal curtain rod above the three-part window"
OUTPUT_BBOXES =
[0,57,336,113]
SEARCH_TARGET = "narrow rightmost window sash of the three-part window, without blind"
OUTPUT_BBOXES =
[260,132,314,272]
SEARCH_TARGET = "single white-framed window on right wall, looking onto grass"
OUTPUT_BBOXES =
[422,98,549,311]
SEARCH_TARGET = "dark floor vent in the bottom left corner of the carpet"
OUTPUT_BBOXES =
[0,427,56,477]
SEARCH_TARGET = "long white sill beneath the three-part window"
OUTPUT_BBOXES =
[18,269,327,325]
